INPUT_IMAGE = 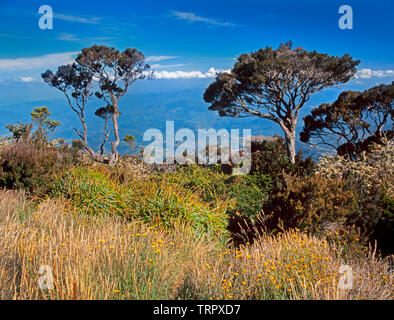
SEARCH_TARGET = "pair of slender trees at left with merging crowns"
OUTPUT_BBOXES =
[41,45,153,165]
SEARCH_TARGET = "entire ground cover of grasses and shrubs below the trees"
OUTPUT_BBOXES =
[0,138,394,299]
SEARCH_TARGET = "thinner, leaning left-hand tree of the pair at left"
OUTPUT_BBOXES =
[41,63,98,160]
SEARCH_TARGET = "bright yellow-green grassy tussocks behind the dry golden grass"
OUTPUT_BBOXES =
[51,167,234,237]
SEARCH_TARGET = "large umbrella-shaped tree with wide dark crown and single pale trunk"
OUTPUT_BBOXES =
[204,41,360,163]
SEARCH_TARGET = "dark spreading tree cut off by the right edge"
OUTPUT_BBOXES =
[300,82,394,159]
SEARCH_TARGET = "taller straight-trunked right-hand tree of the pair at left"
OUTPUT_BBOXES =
[76,45,153,165]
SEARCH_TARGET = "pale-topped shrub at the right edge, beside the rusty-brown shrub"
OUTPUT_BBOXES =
[316,141,394,253]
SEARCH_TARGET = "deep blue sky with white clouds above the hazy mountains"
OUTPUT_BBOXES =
[0,0,394,144]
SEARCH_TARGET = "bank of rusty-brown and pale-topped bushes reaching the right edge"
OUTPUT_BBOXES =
[261,143,394,254]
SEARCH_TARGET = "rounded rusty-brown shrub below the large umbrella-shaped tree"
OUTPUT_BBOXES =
[264,175,357,233]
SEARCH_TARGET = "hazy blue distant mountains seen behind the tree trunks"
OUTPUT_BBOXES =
[0,88,327,159]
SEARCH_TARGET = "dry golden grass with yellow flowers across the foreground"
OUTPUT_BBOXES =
[0,191,394,299]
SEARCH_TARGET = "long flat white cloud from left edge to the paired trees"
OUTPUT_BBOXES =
[0,51,78,71]
